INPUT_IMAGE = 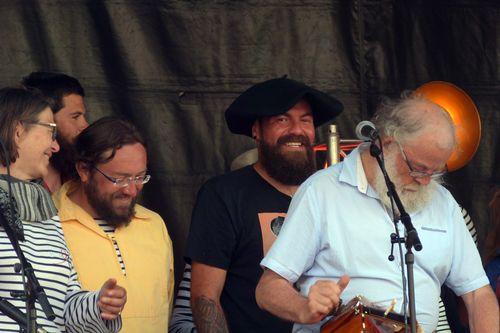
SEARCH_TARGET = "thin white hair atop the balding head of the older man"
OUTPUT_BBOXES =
[372,92,456,145]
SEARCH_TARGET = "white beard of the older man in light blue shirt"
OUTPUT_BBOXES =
[373,150,441,215]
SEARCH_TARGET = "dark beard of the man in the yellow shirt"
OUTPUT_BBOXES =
[82,174,137,228]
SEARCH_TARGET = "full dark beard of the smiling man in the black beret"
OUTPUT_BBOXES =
[259,135,316,185]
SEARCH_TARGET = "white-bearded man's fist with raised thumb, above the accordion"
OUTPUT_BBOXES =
[302,275,350,324]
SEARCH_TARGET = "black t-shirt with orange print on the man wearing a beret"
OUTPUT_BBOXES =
[186,166,293,333]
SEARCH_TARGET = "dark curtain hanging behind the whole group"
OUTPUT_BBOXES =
[0,0,500,286]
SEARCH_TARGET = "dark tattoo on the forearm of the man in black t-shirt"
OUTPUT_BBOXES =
[192,296,229,333]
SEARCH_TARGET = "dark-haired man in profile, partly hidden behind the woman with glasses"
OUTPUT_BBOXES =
[22,72,88,193]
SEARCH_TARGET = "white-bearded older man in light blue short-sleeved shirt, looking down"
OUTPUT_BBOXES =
[256,97,499,332]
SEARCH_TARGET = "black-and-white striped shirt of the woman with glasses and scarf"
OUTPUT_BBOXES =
[0,216,121,332]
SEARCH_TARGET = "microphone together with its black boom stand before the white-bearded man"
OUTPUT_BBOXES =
[356,121,422,333]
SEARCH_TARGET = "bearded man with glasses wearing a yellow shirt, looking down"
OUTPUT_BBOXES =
[54,117,174,333]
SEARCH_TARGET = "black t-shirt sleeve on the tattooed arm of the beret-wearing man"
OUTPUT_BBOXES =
[185,182,236,270]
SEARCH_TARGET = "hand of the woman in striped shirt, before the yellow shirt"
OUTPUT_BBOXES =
[97,279,127,320]
